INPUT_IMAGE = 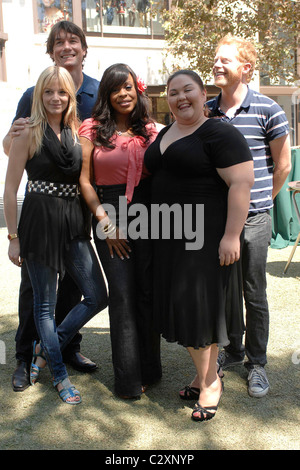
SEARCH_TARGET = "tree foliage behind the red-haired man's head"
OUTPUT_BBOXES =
[164,0,300,83]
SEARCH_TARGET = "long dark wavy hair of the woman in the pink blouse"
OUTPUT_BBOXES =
[92,64,153,148]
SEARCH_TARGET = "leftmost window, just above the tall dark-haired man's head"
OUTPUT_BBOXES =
[34,0,73,33]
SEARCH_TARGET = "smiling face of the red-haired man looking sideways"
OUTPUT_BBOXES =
[213,44,250,88]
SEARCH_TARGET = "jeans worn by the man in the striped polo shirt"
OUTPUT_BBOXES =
[226,212,272,368]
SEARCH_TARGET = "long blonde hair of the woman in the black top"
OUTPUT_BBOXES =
[29,65,79,153]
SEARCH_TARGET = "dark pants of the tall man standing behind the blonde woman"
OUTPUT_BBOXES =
[16,263,82,363]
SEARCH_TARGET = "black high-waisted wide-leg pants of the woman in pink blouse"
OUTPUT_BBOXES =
[93,181,161,396]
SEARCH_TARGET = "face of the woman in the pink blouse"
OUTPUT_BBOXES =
[110,73,137,116]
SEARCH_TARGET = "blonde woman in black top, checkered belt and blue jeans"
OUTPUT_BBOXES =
[4,66,107,405]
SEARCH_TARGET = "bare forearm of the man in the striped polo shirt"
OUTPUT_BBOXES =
[270,135,292,199]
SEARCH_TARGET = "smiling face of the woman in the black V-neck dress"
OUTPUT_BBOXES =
[168,74,206,124]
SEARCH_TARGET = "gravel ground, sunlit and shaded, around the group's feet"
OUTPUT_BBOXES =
[0,235,300,453]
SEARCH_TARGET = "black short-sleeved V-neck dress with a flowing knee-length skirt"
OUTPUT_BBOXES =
[145,119,252,348]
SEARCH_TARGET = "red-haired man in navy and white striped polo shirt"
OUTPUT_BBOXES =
[207,35,291,398]
